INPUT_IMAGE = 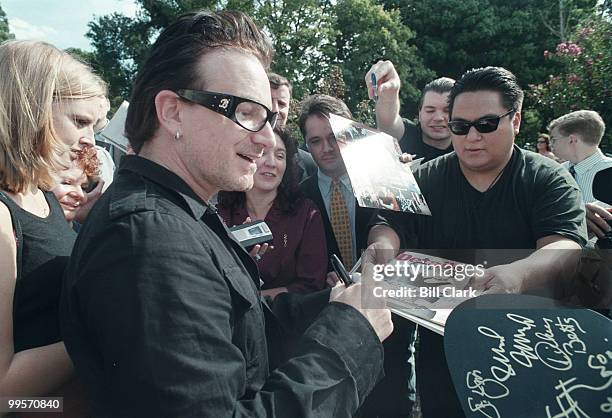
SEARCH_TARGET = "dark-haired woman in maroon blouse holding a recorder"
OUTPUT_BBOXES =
[218,131,327,297]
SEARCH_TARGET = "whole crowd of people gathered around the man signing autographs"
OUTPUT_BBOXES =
[0,7,612,417]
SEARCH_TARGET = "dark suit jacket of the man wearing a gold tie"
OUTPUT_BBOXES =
[300,172,375,271]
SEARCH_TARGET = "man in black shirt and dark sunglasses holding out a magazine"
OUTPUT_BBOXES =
[369,67,586,417]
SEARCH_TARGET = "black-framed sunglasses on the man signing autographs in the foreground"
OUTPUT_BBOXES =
[176,89,278,132]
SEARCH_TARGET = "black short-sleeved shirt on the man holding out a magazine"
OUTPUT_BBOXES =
[380,146,586,417]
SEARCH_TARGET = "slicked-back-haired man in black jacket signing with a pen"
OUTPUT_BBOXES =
[61,11,392,418]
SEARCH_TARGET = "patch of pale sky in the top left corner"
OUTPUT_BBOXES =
[0,0,137,51]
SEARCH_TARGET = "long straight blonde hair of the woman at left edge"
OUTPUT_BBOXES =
[0,41,106,192]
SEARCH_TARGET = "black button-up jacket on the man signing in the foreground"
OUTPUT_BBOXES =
[61,156,382,418]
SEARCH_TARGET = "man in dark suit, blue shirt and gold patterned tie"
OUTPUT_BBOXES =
[298,94,415,417]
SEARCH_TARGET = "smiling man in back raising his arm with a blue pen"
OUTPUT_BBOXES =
[366,61,455,163]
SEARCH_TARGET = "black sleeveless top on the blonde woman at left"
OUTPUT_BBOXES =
[0,192,76,353]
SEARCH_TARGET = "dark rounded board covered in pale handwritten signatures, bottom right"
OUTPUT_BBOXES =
[444,295,612,418]
